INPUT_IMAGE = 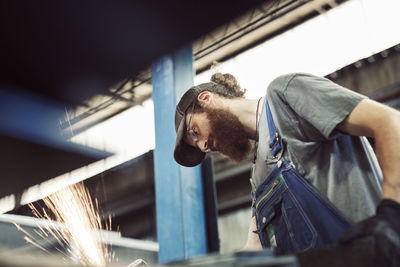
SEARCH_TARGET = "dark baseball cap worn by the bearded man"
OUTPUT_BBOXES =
[174,82,227,167]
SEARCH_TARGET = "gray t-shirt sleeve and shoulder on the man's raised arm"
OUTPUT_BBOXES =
[268,73,366,141]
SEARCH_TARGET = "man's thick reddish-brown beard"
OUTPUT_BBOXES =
[205,108,252,162]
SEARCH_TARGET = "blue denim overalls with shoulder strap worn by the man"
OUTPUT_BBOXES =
[254,101,350,255]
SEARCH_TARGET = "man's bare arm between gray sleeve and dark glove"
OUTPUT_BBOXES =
[338,99,400,202]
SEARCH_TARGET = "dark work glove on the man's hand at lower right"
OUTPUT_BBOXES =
[339,199,400,266]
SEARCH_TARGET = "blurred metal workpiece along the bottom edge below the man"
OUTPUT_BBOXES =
[167,237,387,267]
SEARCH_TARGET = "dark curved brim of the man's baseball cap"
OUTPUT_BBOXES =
[174,115,206,167]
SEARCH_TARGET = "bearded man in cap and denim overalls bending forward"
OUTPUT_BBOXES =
[174,73,400,264]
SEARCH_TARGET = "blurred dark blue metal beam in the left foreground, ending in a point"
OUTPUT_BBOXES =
[0,89,112,200]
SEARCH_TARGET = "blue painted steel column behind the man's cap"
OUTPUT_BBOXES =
[152,45,207,264]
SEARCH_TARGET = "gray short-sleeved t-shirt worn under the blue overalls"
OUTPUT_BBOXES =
[252,73,382,222]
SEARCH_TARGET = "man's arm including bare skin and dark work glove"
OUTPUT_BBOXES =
[338,99,400,266]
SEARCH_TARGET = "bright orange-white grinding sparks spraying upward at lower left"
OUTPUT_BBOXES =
[27,183,112,266]
